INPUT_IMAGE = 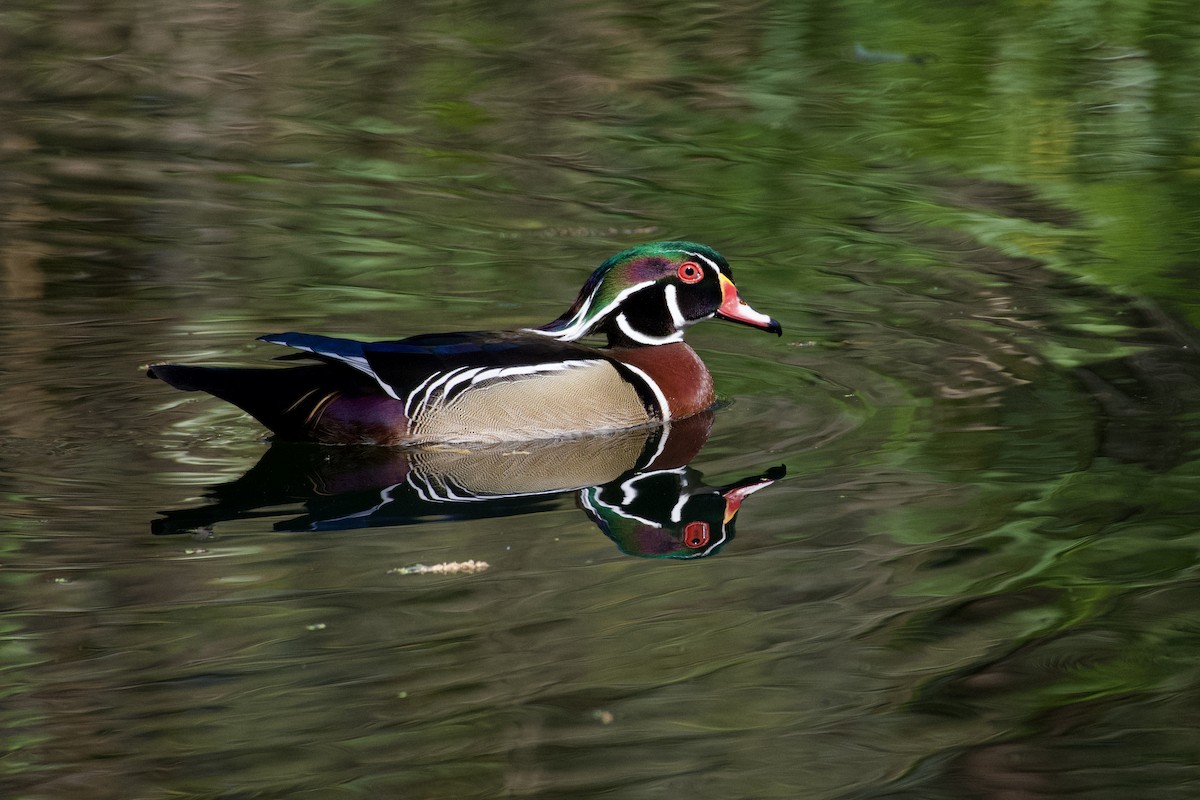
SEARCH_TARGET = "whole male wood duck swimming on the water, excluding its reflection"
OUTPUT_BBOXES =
[148,241,782,445]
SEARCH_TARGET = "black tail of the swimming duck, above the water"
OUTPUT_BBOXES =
[146,363,379,440]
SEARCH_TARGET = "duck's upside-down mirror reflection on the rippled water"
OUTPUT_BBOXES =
[151,414,786,559]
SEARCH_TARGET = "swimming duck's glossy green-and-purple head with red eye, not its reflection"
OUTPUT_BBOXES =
[530,241,784,347]
